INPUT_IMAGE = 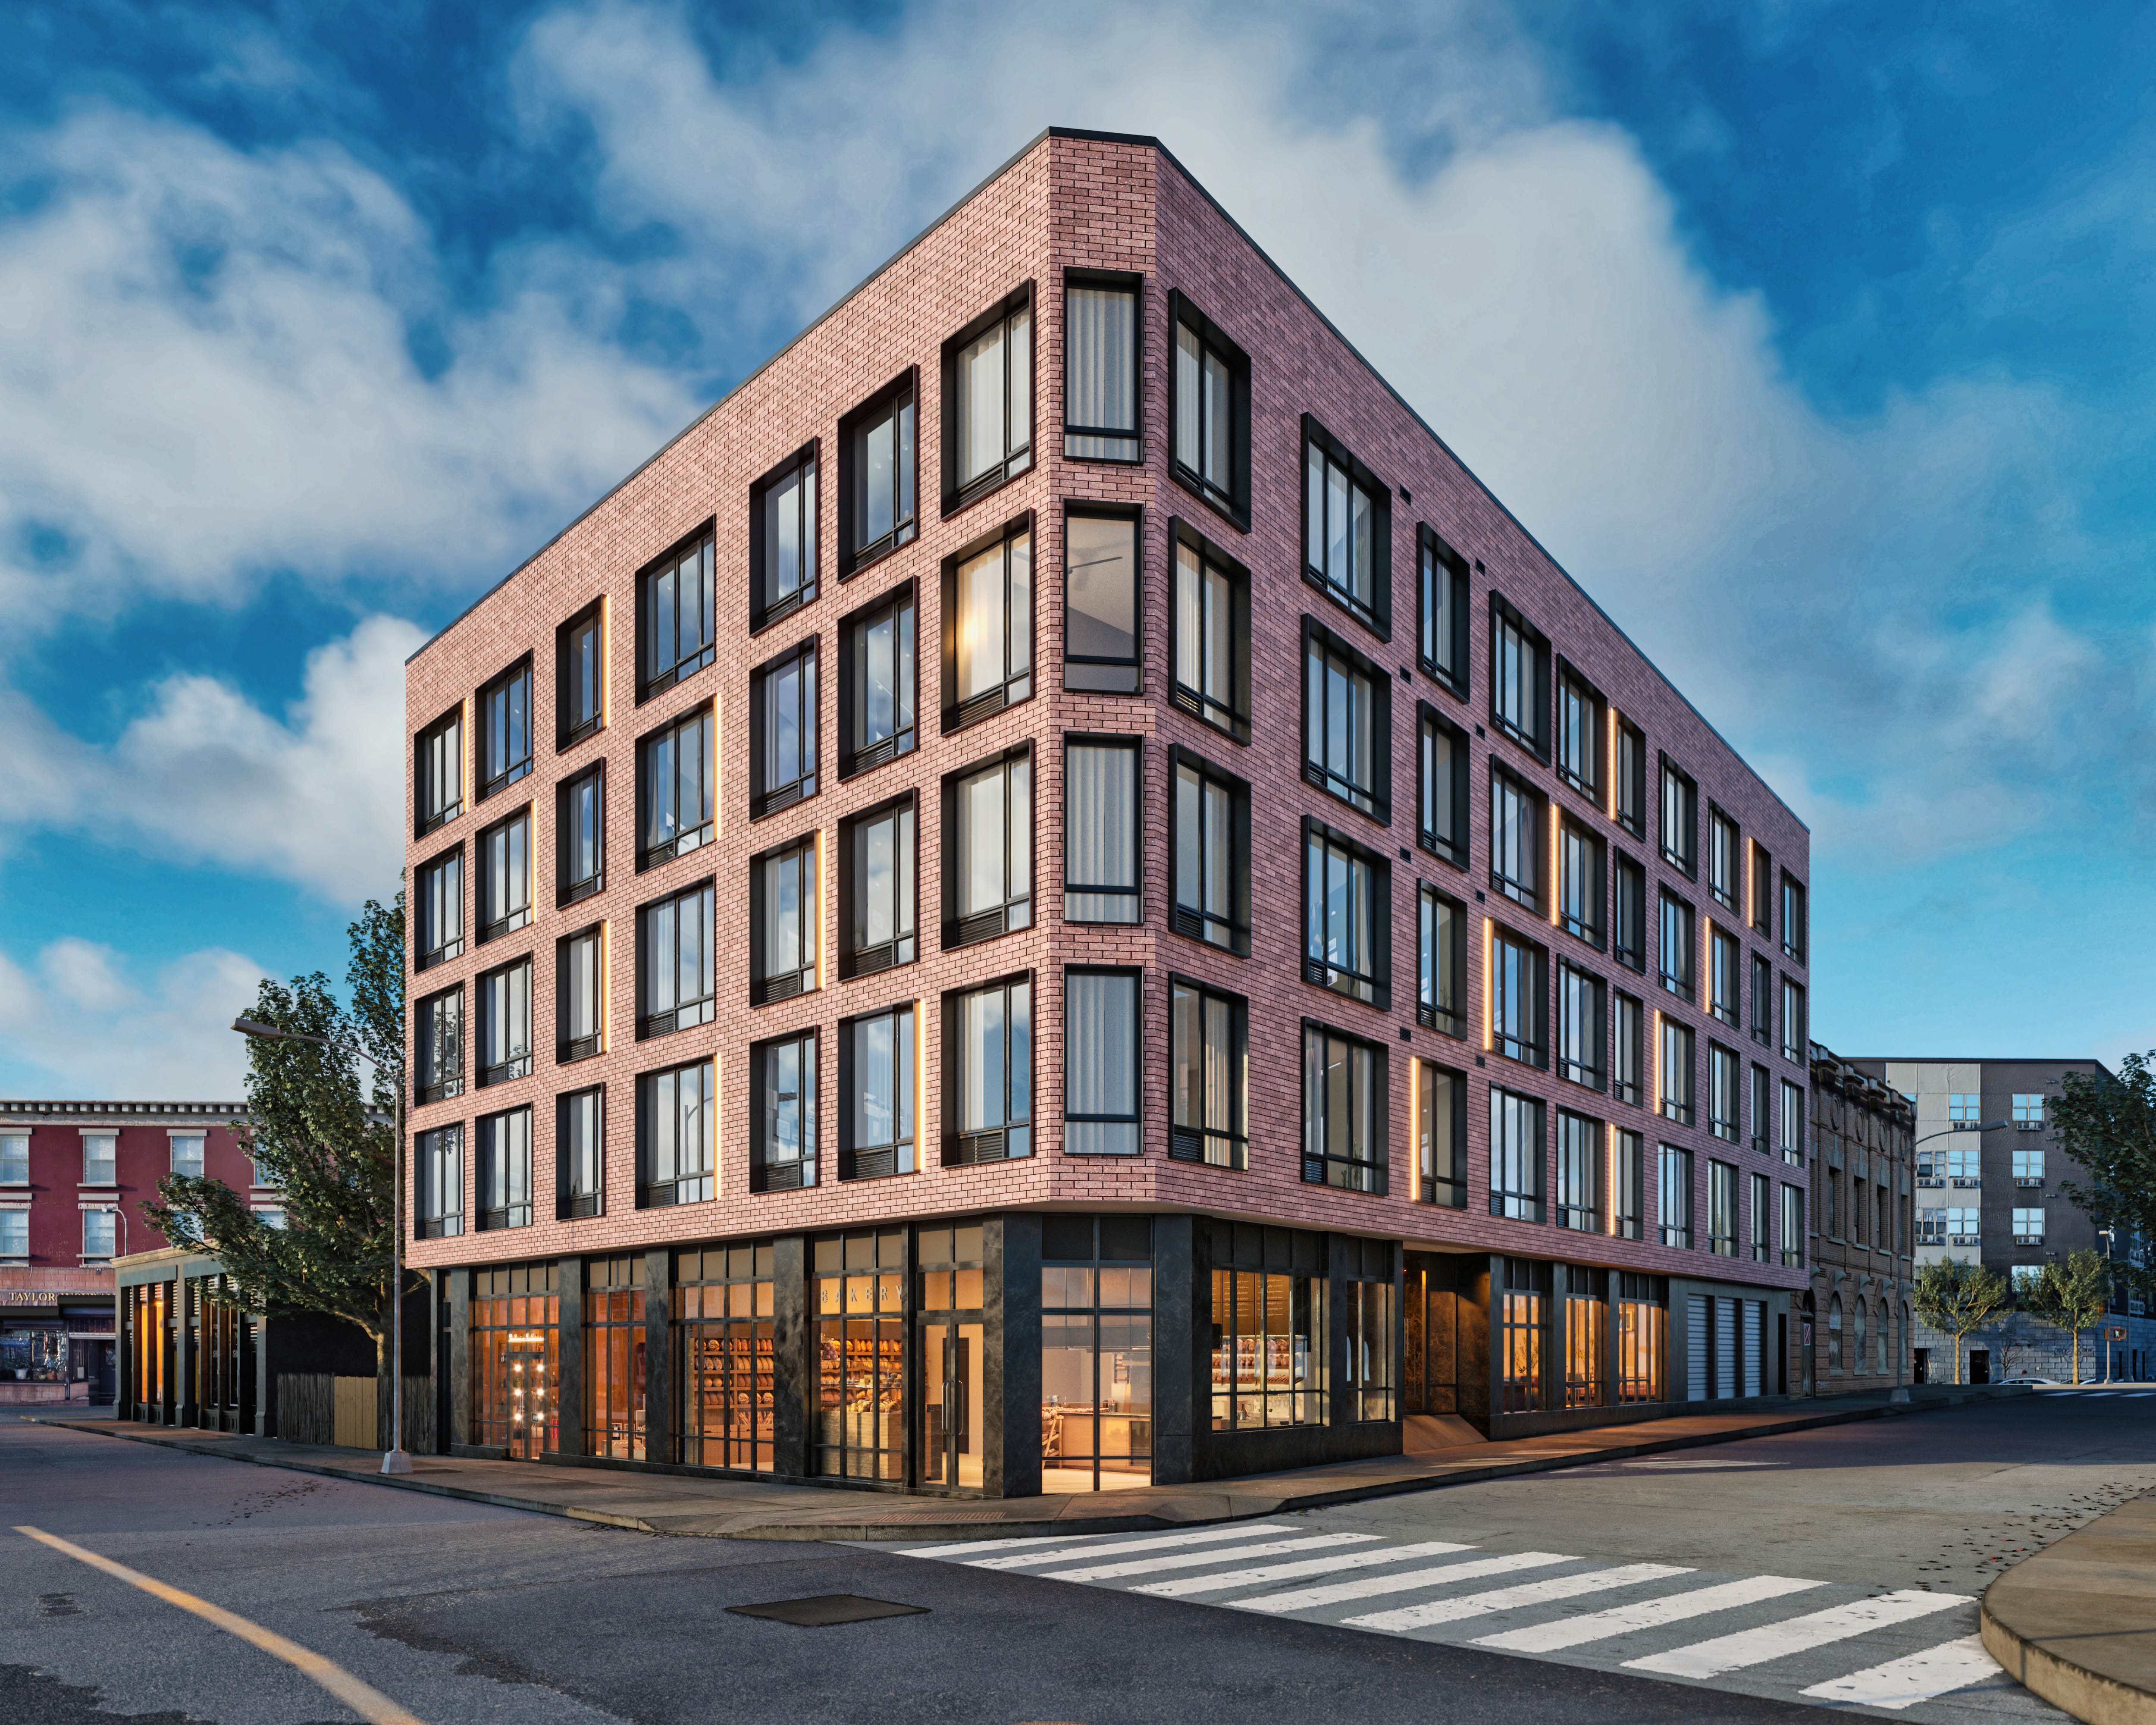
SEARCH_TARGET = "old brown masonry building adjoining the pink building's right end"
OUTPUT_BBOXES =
[1792,1041,1917,1395]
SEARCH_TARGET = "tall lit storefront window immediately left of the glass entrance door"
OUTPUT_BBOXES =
[815,1229,901,1484]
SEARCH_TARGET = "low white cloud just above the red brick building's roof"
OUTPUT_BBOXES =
[0,938,263,1102]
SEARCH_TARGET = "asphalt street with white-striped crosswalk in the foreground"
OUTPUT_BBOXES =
[0,1393,2156,1725]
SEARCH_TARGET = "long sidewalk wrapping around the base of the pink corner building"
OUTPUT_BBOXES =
[24,1384,2029,1540]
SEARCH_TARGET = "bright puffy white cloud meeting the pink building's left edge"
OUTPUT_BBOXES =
[0,617,420,901]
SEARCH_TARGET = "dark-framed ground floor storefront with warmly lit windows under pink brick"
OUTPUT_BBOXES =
[431,1212,1789,1496]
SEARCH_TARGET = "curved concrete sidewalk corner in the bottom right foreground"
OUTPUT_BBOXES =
[1981,1499,2156,1725]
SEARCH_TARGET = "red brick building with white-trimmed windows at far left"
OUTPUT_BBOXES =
[0,1100,263,1404]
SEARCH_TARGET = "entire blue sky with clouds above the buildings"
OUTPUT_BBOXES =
[0,0,2156,1098]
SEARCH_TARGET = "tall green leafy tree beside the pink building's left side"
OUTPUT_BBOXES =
[142,893,416,1432]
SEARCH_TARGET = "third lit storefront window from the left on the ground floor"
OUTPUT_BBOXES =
[675,1242,778,1473]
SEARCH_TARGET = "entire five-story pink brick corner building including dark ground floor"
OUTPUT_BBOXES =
[405,132,1809,1496]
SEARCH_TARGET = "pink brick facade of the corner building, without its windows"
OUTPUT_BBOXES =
[405,134,1809,1477]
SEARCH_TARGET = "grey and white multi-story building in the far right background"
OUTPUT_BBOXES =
[1850,1059,2156,1384]
